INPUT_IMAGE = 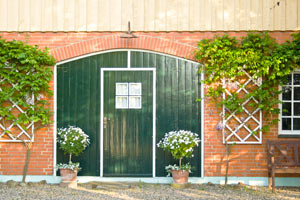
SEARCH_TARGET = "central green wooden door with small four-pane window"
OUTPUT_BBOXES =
[103,71,153,177]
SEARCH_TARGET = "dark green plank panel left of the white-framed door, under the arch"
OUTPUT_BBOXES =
[57,51,127,176]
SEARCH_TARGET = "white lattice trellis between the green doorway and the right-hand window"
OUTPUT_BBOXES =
[223,70,262,144]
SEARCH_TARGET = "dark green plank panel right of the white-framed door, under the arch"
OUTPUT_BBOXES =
[131,51,201,177]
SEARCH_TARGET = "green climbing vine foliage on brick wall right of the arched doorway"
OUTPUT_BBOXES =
[195,32,300,131]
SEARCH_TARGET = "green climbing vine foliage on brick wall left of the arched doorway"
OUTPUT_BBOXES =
[0,38,55,133]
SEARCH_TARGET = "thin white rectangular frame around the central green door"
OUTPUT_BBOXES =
[100,68,156,177]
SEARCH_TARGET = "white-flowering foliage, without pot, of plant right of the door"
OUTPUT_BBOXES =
[157,130,200,172]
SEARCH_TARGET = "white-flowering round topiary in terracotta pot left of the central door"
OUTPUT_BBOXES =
[56,126,90,187]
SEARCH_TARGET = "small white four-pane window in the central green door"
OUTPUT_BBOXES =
[116,83,142,109]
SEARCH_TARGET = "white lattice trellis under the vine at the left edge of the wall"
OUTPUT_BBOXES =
[0,73,34,142]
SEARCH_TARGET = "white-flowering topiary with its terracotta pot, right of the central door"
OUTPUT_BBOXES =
[157,130,200,184]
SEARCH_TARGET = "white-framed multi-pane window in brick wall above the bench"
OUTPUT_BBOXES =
[280,72,300,135]
